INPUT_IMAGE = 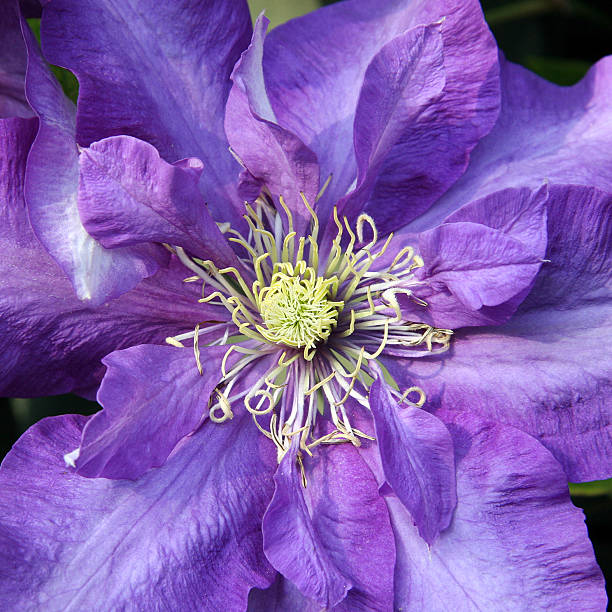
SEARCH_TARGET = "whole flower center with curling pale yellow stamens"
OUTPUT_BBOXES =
[166,195,453,461]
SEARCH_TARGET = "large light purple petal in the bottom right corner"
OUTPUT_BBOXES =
[387,412,606,612]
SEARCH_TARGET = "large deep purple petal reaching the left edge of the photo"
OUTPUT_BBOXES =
[0,112,227,397]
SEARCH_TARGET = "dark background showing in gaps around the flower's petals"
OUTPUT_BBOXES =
[0,0,612,595]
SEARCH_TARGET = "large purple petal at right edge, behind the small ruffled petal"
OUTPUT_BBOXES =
[385,187,612,481]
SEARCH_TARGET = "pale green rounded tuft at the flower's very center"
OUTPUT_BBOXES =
[260,261,344,348]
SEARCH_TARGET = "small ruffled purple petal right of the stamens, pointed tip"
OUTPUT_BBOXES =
[392,186,549,329]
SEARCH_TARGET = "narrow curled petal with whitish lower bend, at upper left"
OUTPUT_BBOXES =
[24,20,166,306]
